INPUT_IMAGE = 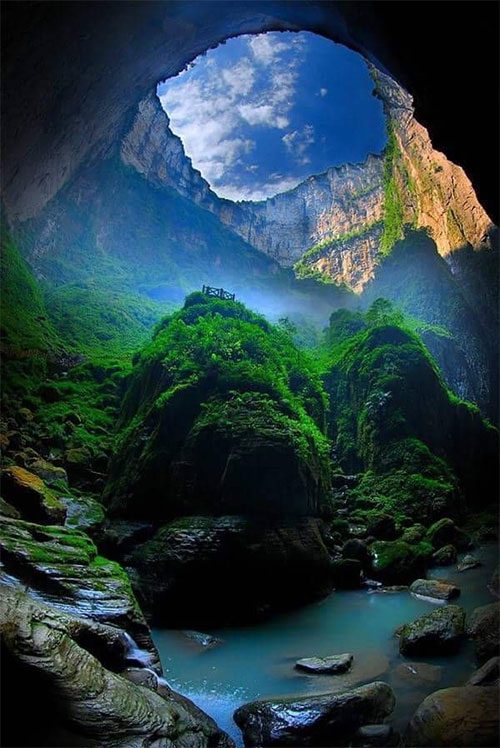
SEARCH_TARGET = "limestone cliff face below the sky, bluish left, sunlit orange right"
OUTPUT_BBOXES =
[120,88,493,292]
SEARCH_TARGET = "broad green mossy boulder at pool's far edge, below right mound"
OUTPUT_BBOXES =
[370,540,431,584]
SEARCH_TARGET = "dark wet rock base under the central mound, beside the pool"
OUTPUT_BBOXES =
[124,516,334,628]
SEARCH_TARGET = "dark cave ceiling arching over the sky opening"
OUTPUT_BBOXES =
[2,0,498,221]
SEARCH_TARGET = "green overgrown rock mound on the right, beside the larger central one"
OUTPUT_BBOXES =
[324,302,498,522]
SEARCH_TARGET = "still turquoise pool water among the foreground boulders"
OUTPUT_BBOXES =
[153,545,498,746]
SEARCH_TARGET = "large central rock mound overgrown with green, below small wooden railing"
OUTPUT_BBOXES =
[105,293,329,521]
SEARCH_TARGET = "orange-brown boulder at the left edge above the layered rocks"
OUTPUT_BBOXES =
[1,466,66,524]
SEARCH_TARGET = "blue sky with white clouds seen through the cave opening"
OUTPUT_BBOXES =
[157,32,385,200]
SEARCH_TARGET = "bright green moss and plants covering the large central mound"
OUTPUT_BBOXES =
[106,293,330,518]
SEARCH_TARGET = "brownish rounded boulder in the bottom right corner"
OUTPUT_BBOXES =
[404,686,499,748]
